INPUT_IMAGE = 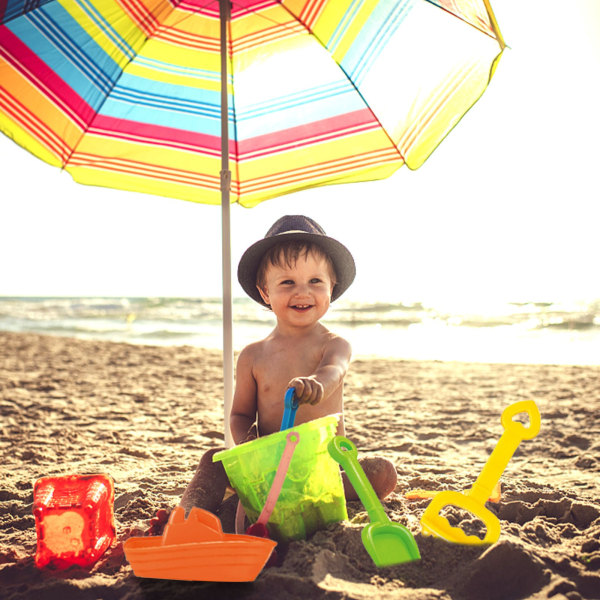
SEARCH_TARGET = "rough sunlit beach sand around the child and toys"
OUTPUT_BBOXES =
[0,333,600,600]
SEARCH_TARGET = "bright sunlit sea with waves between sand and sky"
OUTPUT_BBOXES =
[0,296,600,365]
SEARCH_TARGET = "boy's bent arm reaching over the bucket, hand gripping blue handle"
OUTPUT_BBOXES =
[288,337,352,404]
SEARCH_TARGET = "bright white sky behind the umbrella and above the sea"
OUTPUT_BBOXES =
[0,0,600,307]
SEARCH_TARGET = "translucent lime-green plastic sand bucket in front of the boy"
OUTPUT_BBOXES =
[213,415,348,542]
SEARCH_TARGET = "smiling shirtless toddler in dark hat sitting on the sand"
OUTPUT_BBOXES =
[153,215,397,536]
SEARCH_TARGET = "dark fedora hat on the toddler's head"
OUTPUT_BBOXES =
[238,215,356,306]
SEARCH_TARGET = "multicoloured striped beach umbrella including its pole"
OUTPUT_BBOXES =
[0,0,504,442]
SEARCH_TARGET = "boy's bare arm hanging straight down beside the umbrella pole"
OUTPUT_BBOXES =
[229,348,257,444]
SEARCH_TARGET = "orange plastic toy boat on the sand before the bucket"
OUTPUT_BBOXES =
[123,506,277,581]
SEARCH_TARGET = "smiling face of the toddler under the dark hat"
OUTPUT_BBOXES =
[257,252,334,326]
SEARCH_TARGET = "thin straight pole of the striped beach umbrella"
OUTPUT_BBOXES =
[219,0,233,448]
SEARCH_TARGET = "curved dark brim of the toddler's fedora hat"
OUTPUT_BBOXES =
[238,231,356,306]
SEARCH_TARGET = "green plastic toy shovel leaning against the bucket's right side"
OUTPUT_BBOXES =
[327,435,421,567]
